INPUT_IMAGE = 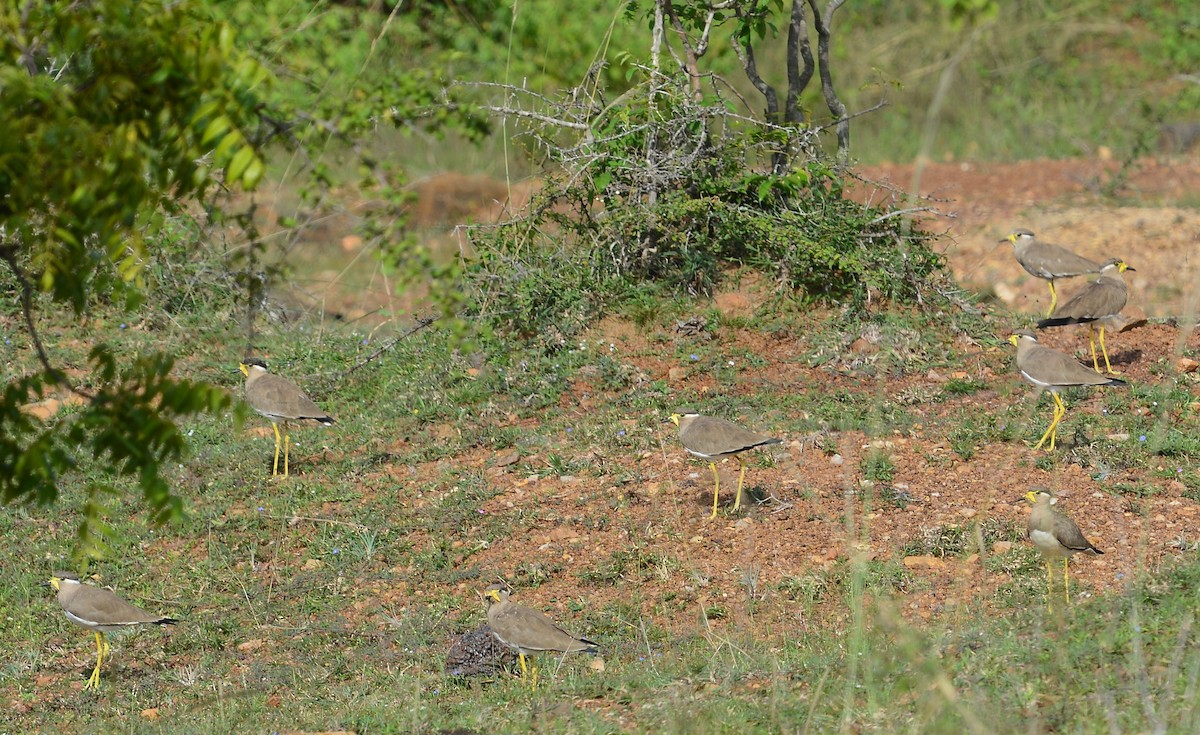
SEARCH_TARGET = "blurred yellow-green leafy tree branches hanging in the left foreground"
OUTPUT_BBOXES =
[0,0,270,555]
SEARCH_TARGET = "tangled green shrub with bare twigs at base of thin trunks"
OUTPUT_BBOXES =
[466,73,947,346]
